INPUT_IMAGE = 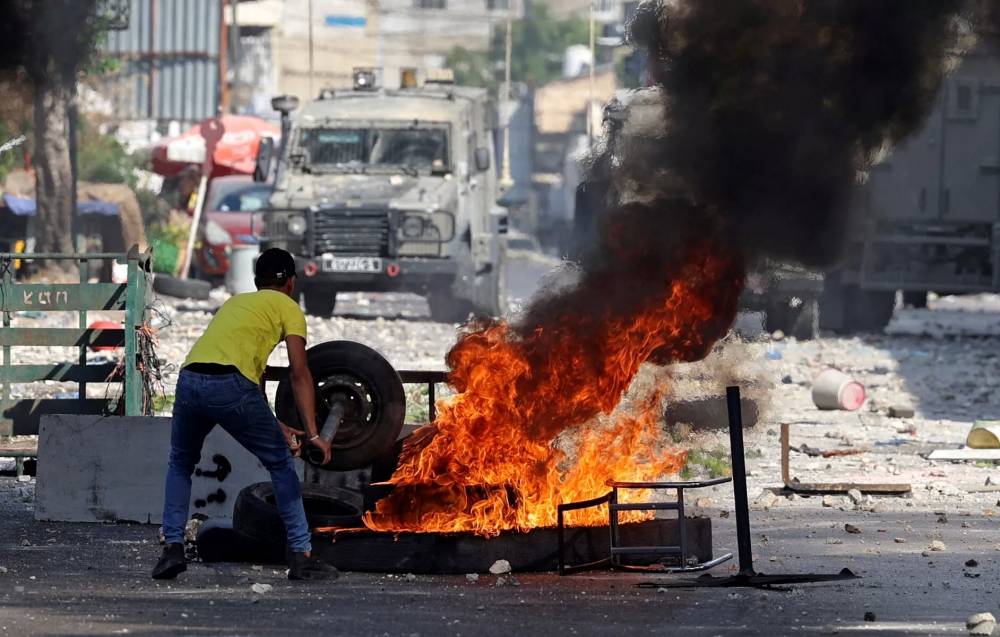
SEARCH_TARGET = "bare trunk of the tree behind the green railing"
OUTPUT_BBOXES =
[34,72,76,252]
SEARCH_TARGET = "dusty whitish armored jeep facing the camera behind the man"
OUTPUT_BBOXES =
[256,70,507,322]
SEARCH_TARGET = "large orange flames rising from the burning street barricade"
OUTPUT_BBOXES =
[365,246,742,536]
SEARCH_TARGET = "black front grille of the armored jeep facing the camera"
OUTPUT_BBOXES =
[313,209,389,257]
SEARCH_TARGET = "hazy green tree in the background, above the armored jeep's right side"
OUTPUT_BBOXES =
[447,2,590,91]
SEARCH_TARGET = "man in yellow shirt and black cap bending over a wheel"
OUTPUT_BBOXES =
[153,248,338,579]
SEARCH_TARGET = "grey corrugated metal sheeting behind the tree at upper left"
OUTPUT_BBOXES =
[100,0,222,122]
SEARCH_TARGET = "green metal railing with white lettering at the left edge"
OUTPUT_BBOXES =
[0,247,151,436]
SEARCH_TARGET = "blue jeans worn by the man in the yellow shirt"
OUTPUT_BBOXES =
[163,370,312,552]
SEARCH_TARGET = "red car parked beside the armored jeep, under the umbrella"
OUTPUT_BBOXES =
[195,175,273,278]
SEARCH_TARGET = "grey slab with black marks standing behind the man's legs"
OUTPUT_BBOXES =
[35,415,301,524]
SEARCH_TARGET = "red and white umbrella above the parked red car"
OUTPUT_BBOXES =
[153,115,281,178]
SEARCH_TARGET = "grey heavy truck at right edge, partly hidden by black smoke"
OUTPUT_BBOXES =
[821,39,1000,331]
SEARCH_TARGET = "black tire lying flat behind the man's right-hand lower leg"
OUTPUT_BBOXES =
[233,482,362,552]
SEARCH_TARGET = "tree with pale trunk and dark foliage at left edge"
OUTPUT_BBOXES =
[0,0,106,252]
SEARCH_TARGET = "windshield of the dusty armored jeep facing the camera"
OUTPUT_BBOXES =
[297,127,448,173]
